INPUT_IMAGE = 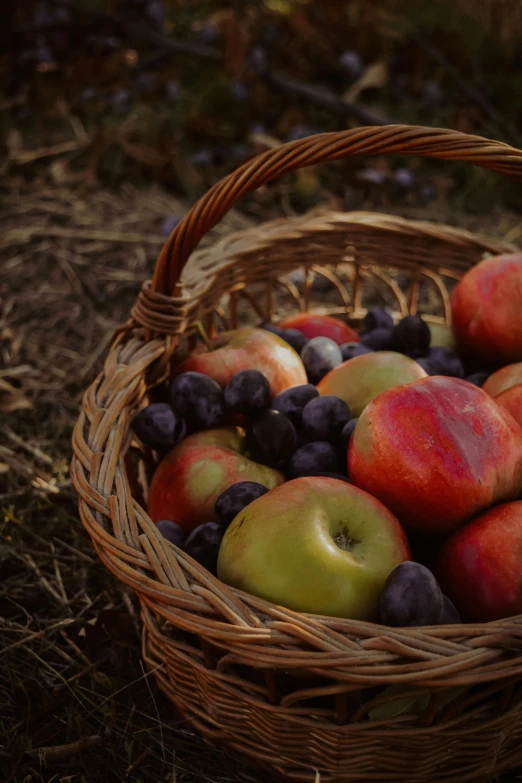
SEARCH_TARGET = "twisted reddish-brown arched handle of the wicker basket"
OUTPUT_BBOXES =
[152,125,522,296]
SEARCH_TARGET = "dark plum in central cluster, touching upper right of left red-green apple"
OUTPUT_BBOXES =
[246,410,297,468]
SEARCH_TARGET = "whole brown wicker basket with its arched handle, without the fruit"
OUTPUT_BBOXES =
[71,126,522,783]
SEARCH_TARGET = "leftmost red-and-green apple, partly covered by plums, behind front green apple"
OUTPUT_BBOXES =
[148,427,284,531]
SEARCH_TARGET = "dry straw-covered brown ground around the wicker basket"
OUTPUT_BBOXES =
[0,175,522,783]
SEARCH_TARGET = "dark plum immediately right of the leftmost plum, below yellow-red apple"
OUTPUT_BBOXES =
[170,371,225,430]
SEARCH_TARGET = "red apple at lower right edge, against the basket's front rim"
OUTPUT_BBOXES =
[435,501,522,622]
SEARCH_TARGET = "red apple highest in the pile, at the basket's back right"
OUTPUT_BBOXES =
[451,253,522,367]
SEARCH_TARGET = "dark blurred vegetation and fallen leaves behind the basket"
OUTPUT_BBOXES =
[0,0,522,220]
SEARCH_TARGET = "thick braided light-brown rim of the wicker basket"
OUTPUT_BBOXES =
[71,205,522,686]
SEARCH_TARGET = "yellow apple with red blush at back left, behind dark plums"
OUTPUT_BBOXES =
[172,327,307,397]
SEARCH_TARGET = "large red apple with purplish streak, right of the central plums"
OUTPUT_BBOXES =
[348,376,522,534]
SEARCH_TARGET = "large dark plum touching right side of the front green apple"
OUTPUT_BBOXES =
[379,560,444,628]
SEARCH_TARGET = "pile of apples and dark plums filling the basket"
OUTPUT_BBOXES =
[133,254,522,626]
